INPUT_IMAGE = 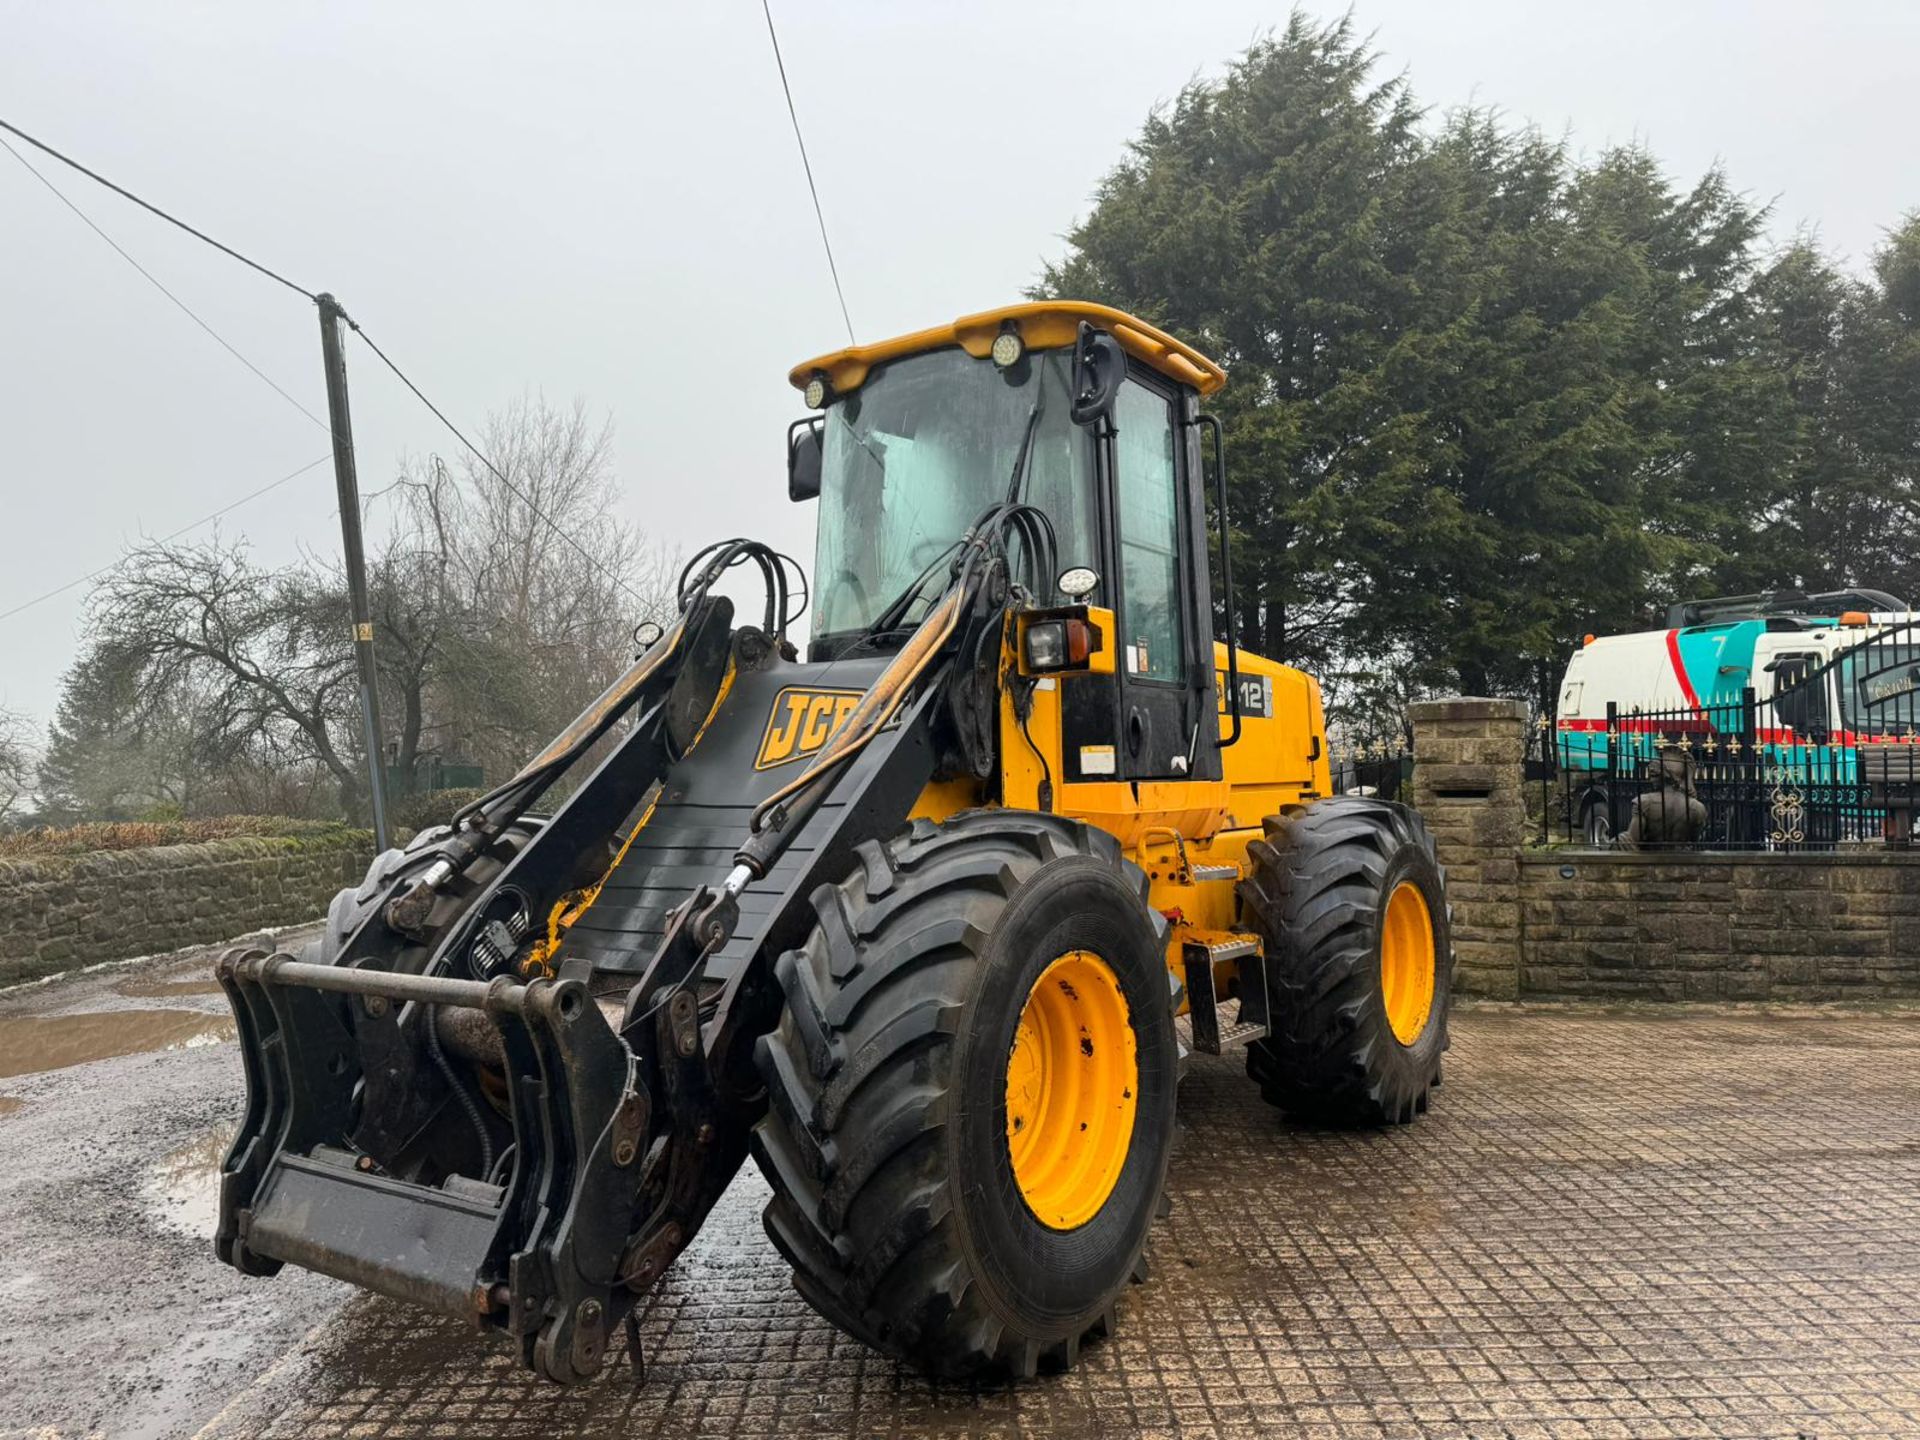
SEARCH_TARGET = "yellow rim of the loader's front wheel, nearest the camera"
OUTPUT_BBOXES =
[1006,950,1140,1231]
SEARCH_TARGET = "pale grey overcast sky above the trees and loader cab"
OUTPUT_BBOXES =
[0,0,1920,733]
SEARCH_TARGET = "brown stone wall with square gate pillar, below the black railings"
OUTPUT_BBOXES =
[1411,699,1920,1002]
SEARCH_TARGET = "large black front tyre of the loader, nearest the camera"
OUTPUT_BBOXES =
[753,810,1177,1379]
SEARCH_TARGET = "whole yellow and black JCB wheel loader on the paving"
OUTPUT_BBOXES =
[217,301,1452,1382]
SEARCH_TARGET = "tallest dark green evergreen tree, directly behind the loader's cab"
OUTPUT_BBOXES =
[1035,13,1421,662]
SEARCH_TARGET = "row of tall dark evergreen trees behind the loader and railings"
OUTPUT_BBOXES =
[1035,13,1920,718]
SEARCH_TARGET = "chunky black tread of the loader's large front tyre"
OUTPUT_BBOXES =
[753,810,1165,1377]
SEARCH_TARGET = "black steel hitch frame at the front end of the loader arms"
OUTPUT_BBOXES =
[215,950,647,1382]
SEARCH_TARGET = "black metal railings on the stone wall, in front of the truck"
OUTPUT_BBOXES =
[1528,622,1920,851]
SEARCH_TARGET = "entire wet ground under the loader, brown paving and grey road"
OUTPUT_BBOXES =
[0,937,1920,1440]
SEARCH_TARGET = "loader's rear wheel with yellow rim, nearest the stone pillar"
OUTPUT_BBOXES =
[1240,795,1453,1125]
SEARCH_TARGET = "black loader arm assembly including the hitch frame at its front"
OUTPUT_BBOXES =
[217,549,1004,1382]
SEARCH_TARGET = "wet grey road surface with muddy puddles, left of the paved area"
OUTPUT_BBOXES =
[0,933,348,1440]
